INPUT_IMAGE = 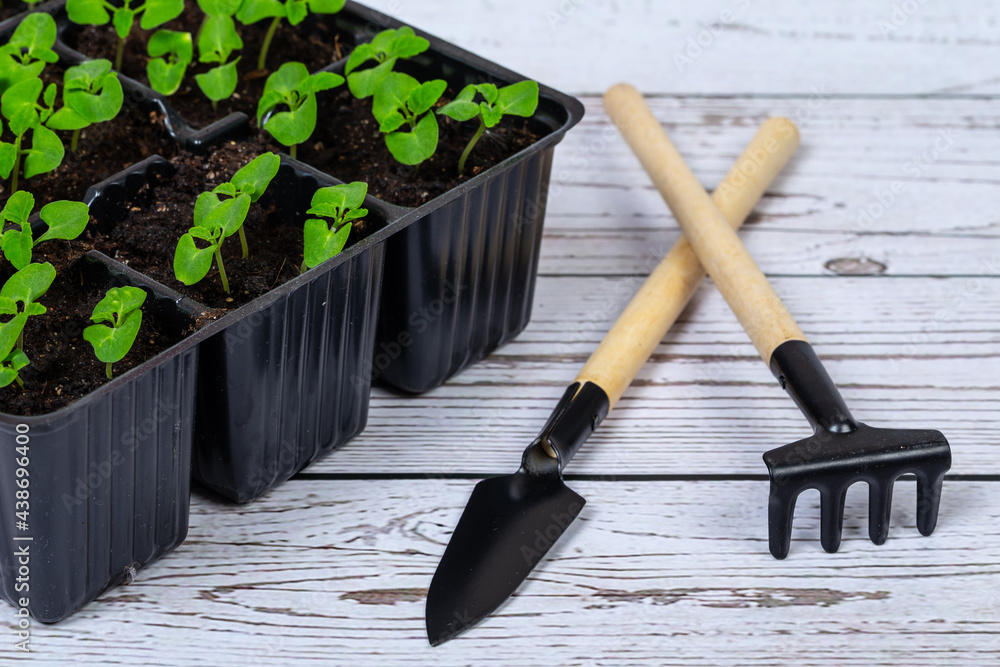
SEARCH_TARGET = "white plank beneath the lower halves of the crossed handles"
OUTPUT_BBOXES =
[308,277,1000,475]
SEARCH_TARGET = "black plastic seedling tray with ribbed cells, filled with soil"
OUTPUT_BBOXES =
[0,2,583,622]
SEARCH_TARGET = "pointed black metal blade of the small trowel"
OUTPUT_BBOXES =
[426,444,586,646]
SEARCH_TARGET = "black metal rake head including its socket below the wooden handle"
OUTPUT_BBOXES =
[764,340,951,558]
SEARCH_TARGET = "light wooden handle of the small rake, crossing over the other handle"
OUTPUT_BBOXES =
[604,84,805,370]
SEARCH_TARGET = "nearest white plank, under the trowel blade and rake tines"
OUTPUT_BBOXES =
[11,480,1000,667]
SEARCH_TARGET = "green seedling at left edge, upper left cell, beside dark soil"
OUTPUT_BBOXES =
[0,78,66,192]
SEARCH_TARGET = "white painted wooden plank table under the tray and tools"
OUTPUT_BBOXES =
[9,0,1000,667]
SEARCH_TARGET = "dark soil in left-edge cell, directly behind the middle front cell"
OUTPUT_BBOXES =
[0,63,177,210]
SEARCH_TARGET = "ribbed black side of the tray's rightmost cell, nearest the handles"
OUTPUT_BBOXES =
[374,146,555,393]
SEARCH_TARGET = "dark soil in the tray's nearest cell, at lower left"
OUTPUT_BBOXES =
[0,241,188,416]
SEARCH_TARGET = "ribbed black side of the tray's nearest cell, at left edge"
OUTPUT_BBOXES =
[0,347,198,623]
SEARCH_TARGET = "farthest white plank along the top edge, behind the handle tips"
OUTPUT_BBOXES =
[386,0,1000,95]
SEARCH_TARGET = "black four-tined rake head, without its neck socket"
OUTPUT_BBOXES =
[764,423,951,558]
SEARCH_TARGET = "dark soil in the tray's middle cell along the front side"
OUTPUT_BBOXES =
[88,141,373,326]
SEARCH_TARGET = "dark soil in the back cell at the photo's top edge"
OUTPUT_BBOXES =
[68,0,350,128]
